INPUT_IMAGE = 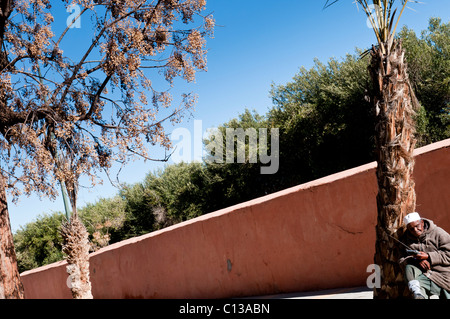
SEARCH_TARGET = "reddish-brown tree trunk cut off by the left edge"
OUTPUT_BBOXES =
[0,173,24,299]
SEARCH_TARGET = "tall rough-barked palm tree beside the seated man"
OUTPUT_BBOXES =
[325,0,418,298]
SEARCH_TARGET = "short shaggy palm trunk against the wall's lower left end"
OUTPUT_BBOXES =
[61,214,93,299]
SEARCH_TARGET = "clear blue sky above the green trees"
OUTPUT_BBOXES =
[9,0,450,231]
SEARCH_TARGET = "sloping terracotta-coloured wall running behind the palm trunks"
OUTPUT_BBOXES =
[21,140,450,298]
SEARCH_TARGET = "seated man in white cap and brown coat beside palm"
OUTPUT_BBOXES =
[402,213,450,299]
